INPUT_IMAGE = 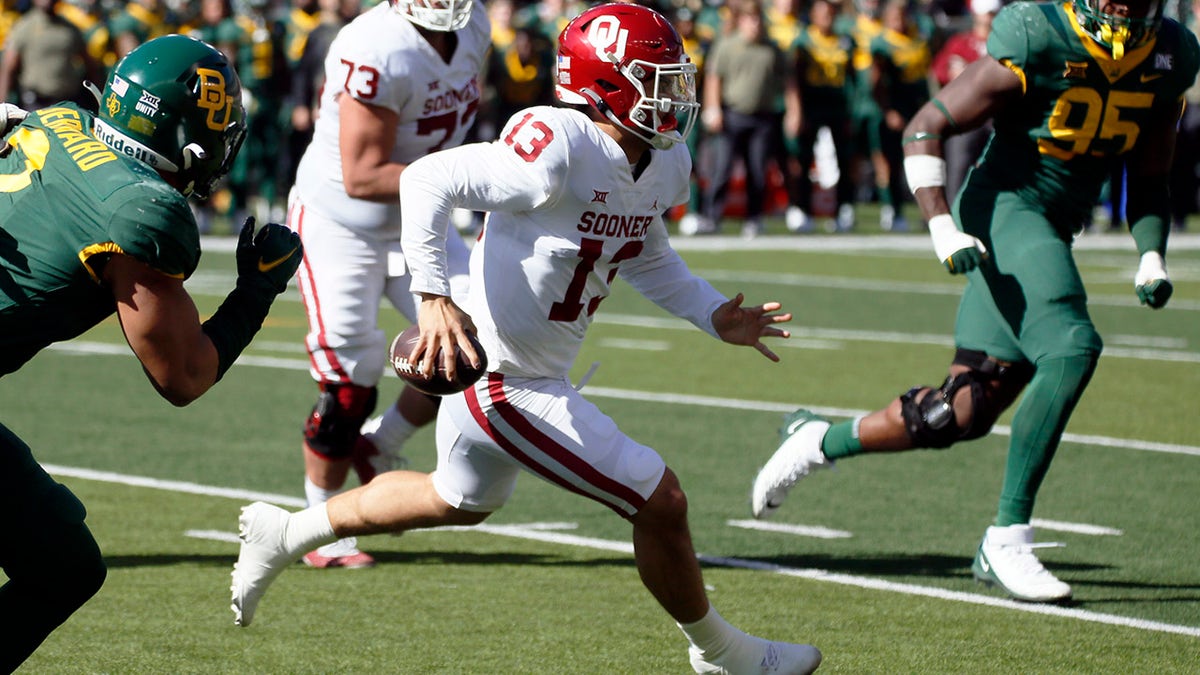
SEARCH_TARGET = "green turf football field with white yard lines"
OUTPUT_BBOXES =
[0,228,1200,674]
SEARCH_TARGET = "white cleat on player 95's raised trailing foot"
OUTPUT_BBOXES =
[750,410,833,519]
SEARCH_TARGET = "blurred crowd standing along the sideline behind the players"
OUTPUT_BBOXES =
[0,0,1200,237]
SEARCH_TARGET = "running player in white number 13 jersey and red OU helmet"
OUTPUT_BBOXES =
[233,4,821,674]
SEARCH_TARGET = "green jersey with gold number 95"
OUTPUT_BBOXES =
[976,2,1200,228]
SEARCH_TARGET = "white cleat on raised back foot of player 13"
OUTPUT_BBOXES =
[229,502,296,626]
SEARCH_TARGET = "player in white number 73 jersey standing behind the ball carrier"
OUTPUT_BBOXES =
[288,0,491,567]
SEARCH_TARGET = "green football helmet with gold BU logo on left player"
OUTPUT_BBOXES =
[95,35,246,199]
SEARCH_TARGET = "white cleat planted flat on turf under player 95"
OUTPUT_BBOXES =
[971,525,1070,602]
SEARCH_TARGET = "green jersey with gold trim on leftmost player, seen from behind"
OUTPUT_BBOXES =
[0,104,200,375]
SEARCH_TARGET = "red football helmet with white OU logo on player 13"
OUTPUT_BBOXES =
[554,2,700,149]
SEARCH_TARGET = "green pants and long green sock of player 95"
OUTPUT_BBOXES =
[955,187,1103,525]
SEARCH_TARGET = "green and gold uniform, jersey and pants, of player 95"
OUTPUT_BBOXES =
[954,2,1200,526]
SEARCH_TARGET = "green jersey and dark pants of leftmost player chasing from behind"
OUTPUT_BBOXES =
[0,104,200,673]
